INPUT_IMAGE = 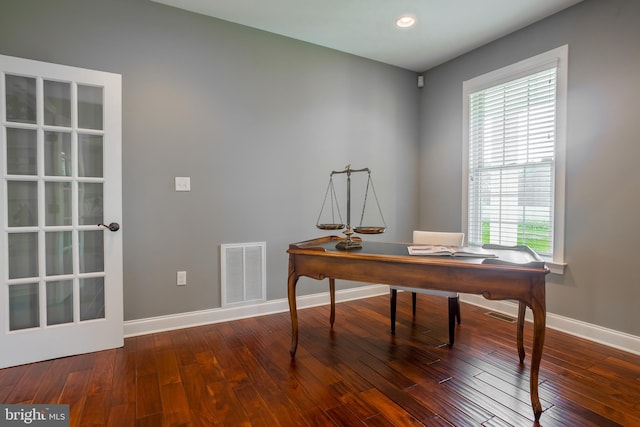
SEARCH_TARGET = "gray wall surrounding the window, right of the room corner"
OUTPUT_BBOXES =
[419,0,640,335]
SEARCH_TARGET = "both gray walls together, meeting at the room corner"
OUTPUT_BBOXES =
[0,0,640,342]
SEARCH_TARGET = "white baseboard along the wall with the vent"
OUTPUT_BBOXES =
[124,285,389,337]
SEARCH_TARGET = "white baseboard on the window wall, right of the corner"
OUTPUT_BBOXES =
[460,294,640,355]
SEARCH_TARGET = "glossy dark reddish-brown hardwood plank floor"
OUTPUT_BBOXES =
[0,293,640,427]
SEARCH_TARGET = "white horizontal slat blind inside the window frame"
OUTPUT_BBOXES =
[467,65,557,256]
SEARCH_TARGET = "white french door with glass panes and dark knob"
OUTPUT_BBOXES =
[0,55,123,368]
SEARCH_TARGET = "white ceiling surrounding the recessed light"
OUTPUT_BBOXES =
[152,0,582,72]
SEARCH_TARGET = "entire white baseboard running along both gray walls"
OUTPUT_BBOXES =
[124,285,640,355]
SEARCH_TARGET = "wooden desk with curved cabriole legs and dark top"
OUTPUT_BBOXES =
[287,236,549,420]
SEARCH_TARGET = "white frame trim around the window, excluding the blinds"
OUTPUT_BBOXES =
[462,45,569,274]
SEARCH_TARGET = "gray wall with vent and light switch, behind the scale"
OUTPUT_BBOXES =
[0,0,419,320]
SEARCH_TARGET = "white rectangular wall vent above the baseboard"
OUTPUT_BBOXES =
[220,242,267,307]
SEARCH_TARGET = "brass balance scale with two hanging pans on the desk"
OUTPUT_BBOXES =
[316,165,386,250]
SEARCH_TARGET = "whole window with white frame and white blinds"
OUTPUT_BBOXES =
[462,46,568,273]
